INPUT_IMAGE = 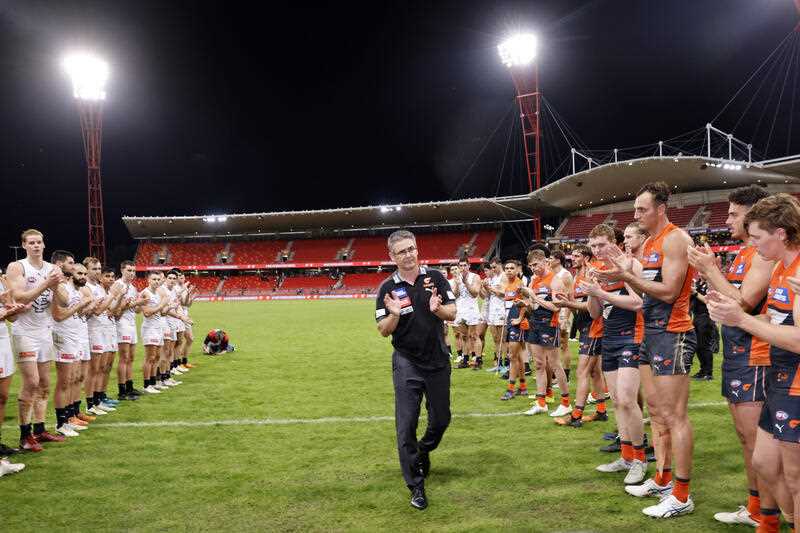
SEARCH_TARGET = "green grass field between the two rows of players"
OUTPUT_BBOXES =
[6,300,746,532]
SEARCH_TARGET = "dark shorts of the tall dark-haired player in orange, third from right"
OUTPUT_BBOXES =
[639,329,697,376]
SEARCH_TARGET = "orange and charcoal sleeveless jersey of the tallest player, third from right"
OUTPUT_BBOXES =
[641,224,694,333]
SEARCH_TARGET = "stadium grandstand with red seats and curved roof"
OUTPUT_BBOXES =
[124,152,800,299]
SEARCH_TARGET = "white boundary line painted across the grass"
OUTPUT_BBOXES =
[93,402,728,429]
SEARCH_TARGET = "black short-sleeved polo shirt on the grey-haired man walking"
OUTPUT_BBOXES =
[375,266,455,370]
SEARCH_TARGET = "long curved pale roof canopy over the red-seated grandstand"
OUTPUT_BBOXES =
[122,152,800,239]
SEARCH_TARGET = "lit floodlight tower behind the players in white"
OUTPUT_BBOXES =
[64,53,108,265]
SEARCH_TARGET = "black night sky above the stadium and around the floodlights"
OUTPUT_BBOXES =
[0,0,800,264]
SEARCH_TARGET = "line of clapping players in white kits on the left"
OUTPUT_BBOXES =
[0,229,197,476]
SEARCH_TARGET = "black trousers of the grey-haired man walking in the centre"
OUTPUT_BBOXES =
[392,352,450,488]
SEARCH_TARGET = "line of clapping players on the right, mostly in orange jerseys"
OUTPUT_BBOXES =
[452,182,800,532]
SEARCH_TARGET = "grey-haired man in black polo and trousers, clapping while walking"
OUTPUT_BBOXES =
[375,230,456,509]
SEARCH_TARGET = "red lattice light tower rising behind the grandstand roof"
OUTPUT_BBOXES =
[497,33,542,240]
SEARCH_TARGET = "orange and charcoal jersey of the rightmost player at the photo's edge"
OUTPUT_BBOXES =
[766,255,800,396]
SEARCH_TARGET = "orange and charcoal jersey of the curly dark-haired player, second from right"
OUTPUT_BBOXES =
[722,246,770,370]
